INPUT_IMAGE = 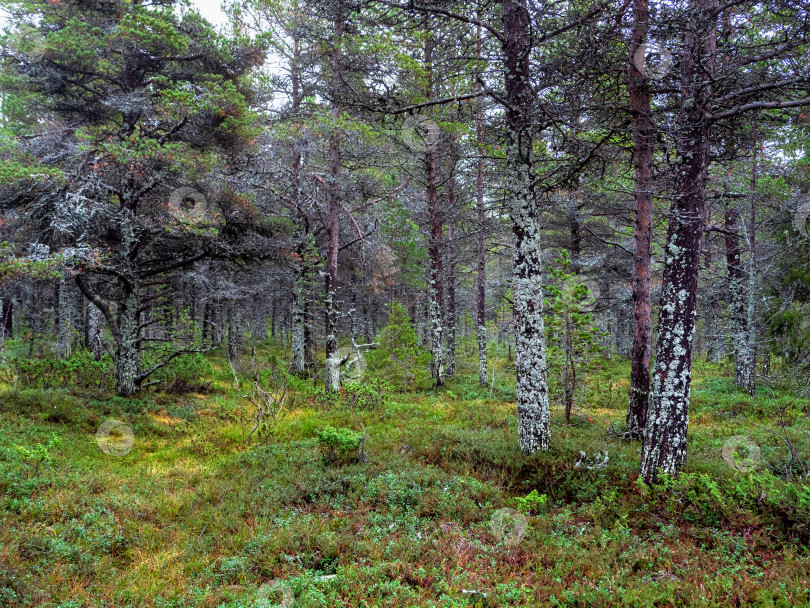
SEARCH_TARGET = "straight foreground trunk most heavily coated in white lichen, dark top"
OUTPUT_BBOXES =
[502,0,551,454]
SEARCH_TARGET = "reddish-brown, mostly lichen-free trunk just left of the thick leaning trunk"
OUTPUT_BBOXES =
[627,0,655,436]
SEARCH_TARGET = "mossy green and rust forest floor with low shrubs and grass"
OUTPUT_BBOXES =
[0,348,810,608]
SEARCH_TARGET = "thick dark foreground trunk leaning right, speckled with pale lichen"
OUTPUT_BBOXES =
[641,0,717,483]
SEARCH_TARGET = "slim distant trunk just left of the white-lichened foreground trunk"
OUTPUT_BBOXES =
[475,25,487,386]
